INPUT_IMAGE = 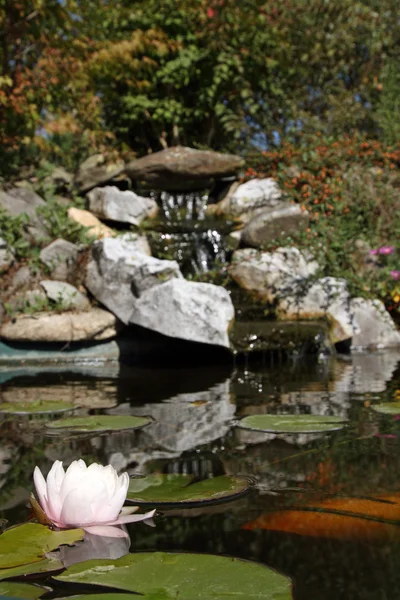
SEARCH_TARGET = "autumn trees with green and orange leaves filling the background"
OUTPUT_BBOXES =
[0,0,399,172]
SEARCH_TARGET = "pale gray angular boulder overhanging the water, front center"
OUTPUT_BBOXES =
[130,278,235,348]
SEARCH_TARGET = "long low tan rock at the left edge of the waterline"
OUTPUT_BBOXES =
[0,308,117,342]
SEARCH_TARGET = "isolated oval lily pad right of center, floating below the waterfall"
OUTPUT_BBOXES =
[238,415,346,433]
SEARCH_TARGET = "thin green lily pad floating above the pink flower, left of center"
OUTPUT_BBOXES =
[46,415,152,433]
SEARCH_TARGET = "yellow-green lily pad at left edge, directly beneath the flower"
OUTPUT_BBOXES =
[0,523,85,573]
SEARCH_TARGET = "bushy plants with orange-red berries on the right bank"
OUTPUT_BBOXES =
[247,136,400,312]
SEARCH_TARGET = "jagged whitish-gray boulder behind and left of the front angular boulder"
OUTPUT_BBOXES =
[85,237,182,323]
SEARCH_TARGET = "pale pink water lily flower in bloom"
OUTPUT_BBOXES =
[33,460,155,537]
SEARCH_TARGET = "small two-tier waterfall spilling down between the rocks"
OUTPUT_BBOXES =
[150,191,230,276]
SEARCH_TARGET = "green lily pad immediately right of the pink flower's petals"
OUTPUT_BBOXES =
[127,474,251,506]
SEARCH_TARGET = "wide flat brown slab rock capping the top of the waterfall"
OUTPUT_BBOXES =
[125,146,244,192]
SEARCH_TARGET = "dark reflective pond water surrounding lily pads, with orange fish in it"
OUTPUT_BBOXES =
[0,352,400,600]
